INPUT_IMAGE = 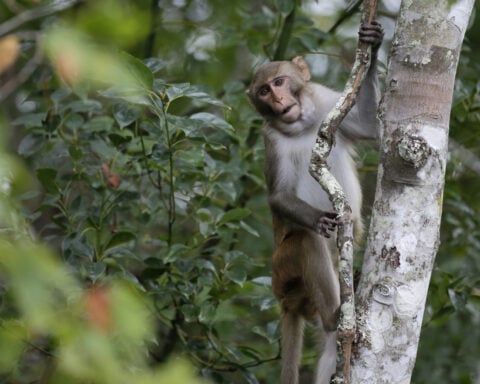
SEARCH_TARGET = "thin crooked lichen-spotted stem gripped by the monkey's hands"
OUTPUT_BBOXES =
[310,0,377,384]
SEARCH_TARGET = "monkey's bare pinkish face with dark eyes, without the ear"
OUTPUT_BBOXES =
[255,75,302,124]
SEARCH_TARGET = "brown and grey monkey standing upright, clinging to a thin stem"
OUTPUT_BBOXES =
[247,22,383,384]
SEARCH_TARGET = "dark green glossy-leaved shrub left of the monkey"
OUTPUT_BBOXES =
[5,36,275,382]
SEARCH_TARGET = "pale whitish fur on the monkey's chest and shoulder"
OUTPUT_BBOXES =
[264,84,361,217]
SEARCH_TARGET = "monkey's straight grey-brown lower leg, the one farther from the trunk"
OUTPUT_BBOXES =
[280,311,304,384]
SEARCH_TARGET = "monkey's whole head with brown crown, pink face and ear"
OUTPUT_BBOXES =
[247,56,311,124]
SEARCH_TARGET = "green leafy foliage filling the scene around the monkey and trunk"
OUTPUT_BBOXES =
[0,0,480,384]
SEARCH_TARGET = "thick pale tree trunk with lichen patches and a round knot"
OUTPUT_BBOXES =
[352,0,474,384]
